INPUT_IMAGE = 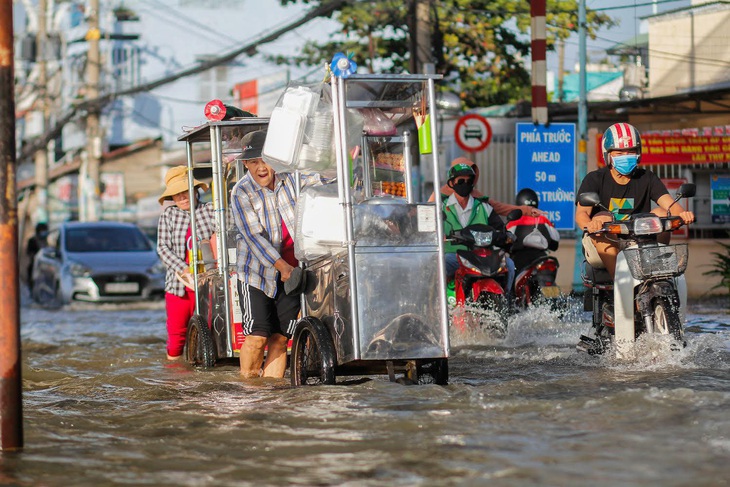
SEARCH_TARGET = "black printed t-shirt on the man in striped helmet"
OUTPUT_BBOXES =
[576,167,669,220]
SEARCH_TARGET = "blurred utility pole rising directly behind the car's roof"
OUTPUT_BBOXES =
[79,0,102,221]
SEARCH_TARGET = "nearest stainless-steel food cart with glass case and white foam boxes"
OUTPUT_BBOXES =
[282,69,449,385]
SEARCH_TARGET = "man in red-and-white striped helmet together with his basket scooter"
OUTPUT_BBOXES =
[575,123,694,357]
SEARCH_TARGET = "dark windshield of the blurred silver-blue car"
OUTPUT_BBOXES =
[66,227,152,252]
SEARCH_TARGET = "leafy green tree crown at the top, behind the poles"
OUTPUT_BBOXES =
[276,0,615,107]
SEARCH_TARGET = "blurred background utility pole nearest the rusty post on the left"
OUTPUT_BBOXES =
[34,0,50,223]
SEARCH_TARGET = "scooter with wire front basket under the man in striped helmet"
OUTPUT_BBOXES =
[577,184,696,358]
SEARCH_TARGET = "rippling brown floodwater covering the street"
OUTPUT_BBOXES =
[5,296,730,486]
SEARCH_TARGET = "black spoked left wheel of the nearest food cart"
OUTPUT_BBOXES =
[291,318,335,386]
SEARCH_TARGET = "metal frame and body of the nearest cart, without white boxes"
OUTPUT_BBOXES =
[291,75,449,385]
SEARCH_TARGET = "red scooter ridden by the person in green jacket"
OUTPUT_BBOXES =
[447,220,521,336]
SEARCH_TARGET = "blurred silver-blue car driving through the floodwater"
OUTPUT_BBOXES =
[32,222,165,304]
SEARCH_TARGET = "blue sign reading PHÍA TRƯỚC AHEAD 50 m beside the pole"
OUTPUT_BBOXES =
[516,123,577,230]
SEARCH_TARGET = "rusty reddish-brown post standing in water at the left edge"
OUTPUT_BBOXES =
[0,0,23,450]
